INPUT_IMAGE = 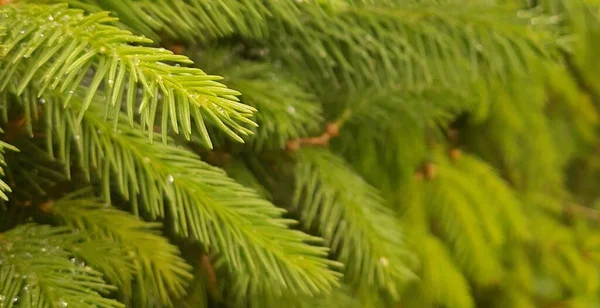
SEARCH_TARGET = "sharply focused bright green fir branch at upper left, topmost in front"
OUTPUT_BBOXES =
[0,4,255,146]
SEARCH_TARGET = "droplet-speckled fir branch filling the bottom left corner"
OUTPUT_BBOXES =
[0,224,124,308]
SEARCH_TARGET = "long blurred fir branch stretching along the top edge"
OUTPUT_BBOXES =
[32,0,559,91]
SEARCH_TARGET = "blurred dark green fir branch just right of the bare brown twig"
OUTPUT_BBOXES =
[331,86,468,199]
